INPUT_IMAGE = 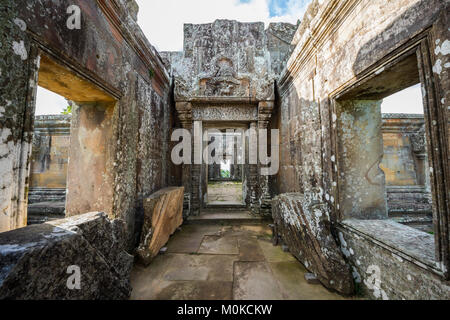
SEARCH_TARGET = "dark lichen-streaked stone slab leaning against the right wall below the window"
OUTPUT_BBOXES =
[272,193,354,295]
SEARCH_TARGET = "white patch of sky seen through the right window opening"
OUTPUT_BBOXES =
[381,84,423,114]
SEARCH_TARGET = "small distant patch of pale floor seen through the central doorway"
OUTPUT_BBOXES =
[208,181,243,205]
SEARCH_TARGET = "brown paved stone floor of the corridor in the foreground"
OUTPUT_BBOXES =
[131,220,344,300]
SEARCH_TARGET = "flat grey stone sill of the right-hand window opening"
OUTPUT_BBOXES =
[340,219,443,275]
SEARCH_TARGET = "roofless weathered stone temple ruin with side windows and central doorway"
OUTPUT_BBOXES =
[0,0,450,300]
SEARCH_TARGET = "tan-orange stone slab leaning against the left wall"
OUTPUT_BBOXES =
[136,187,184,266]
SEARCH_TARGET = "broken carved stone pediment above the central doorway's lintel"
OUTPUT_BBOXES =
[167,20,296,101]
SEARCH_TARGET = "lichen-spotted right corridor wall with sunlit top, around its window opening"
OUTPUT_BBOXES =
[272,0,450,299]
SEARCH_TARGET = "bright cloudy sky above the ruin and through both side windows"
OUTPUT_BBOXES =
[36,0,423,115]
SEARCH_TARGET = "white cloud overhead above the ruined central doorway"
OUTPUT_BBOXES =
[137,0,306,51]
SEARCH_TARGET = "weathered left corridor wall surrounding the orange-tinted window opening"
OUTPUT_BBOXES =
[0,0,178,249]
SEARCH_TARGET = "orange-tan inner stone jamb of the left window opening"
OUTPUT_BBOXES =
[66,103,116,218]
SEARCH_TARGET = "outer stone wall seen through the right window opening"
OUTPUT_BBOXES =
[380,114,433,232]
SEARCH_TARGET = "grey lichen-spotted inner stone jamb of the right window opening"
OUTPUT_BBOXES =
[338,100,388,220]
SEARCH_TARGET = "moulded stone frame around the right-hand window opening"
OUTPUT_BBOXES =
[329,28,450,280]
